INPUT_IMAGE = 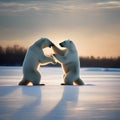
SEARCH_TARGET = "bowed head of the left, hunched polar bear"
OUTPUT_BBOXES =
[34,38,53,48]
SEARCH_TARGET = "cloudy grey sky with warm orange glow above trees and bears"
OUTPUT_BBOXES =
[0,0,120,57]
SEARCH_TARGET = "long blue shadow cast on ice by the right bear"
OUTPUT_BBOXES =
[41,86,79,120]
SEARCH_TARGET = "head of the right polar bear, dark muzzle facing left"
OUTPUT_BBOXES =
[59,40,76,50]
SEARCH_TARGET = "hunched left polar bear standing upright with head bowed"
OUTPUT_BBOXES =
[19,38,55,85]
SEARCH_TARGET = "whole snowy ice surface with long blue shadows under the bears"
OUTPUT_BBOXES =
[0,67,120,120]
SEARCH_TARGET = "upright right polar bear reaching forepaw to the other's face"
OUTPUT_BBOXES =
[52,40,84,85]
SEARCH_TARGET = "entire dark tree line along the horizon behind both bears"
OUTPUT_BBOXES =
[0,45,120,68]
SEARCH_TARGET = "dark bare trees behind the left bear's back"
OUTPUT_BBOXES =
[0,45,26,66]
